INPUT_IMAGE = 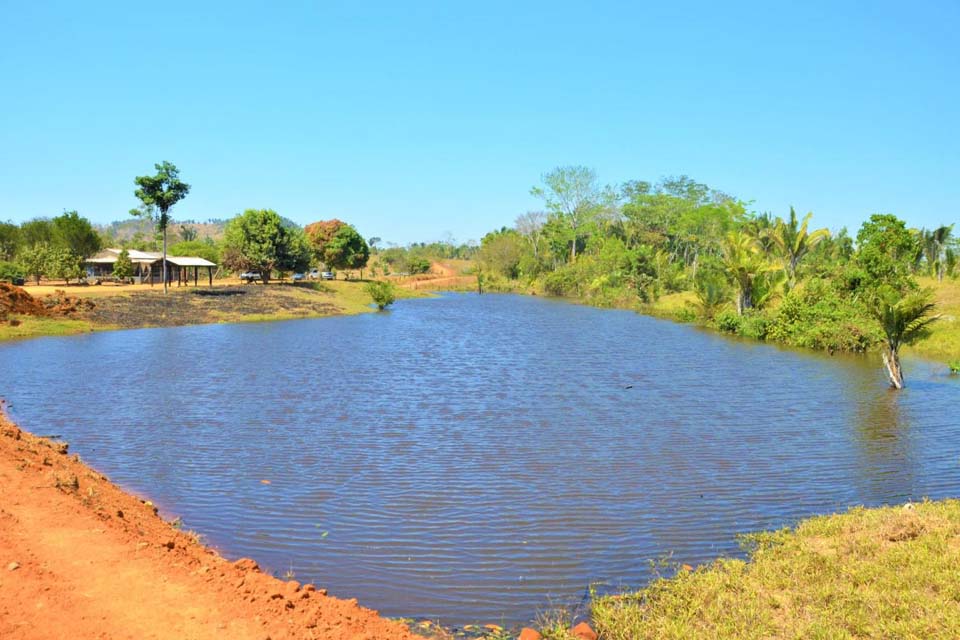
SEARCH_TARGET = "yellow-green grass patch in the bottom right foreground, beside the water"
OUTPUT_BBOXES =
[591,500,960,640]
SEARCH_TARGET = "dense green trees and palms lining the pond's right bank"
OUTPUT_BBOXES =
[477,166,944,388]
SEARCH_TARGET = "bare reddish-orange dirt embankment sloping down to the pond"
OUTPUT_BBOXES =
[0,407,428,640]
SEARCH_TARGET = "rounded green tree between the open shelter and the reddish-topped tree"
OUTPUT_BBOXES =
[223,209,310,284]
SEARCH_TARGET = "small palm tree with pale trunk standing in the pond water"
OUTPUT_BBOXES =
[870,287,940,389]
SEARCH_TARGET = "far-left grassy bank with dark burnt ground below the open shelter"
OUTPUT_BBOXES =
[0,281,427,341]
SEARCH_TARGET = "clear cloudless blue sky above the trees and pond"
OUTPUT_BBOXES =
[0,0,960,243]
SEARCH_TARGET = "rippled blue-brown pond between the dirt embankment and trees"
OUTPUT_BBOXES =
[0,294,960,624]
